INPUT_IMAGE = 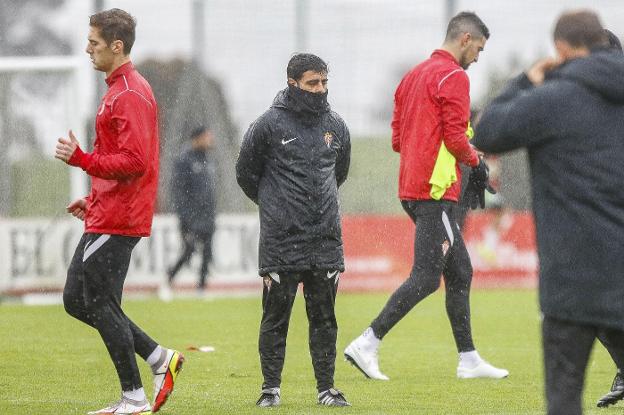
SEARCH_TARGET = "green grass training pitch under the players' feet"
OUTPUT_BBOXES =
[0,290,624,415]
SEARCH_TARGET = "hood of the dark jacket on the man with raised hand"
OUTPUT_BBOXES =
[553,51,624,103]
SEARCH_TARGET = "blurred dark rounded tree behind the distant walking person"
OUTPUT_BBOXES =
[137,59,247,212]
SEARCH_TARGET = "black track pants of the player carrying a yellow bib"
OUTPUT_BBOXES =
[371,201,474,352]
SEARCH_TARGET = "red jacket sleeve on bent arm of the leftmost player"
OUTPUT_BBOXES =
[69,92,155,180]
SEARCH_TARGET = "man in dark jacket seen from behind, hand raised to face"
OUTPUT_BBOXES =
[474,10,624,415]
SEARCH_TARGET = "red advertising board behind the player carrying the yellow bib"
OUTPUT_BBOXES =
[340,211,538,291]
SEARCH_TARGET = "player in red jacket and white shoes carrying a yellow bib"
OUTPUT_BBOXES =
[345,12,509,380]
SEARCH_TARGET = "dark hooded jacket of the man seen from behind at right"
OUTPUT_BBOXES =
[473,51,624,330]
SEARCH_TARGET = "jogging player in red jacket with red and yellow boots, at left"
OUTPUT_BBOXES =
[55,9,184,414]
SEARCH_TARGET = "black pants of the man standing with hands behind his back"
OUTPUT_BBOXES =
[259,271,339,392]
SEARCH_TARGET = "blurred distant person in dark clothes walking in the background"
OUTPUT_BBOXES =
[167,126,216,291]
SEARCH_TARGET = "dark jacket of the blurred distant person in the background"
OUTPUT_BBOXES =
[171,149,216,233]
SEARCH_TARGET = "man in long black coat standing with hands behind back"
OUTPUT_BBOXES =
[236,53,351,406]
